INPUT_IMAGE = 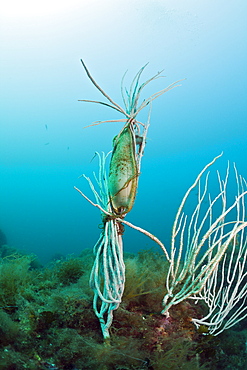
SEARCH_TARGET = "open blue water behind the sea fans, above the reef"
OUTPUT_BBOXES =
[0,0,247,262]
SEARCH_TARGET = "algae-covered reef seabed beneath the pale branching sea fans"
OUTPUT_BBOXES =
[0,246,247,370]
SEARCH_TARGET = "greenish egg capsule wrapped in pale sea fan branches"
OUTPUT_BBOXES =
[108,123,139,215]
